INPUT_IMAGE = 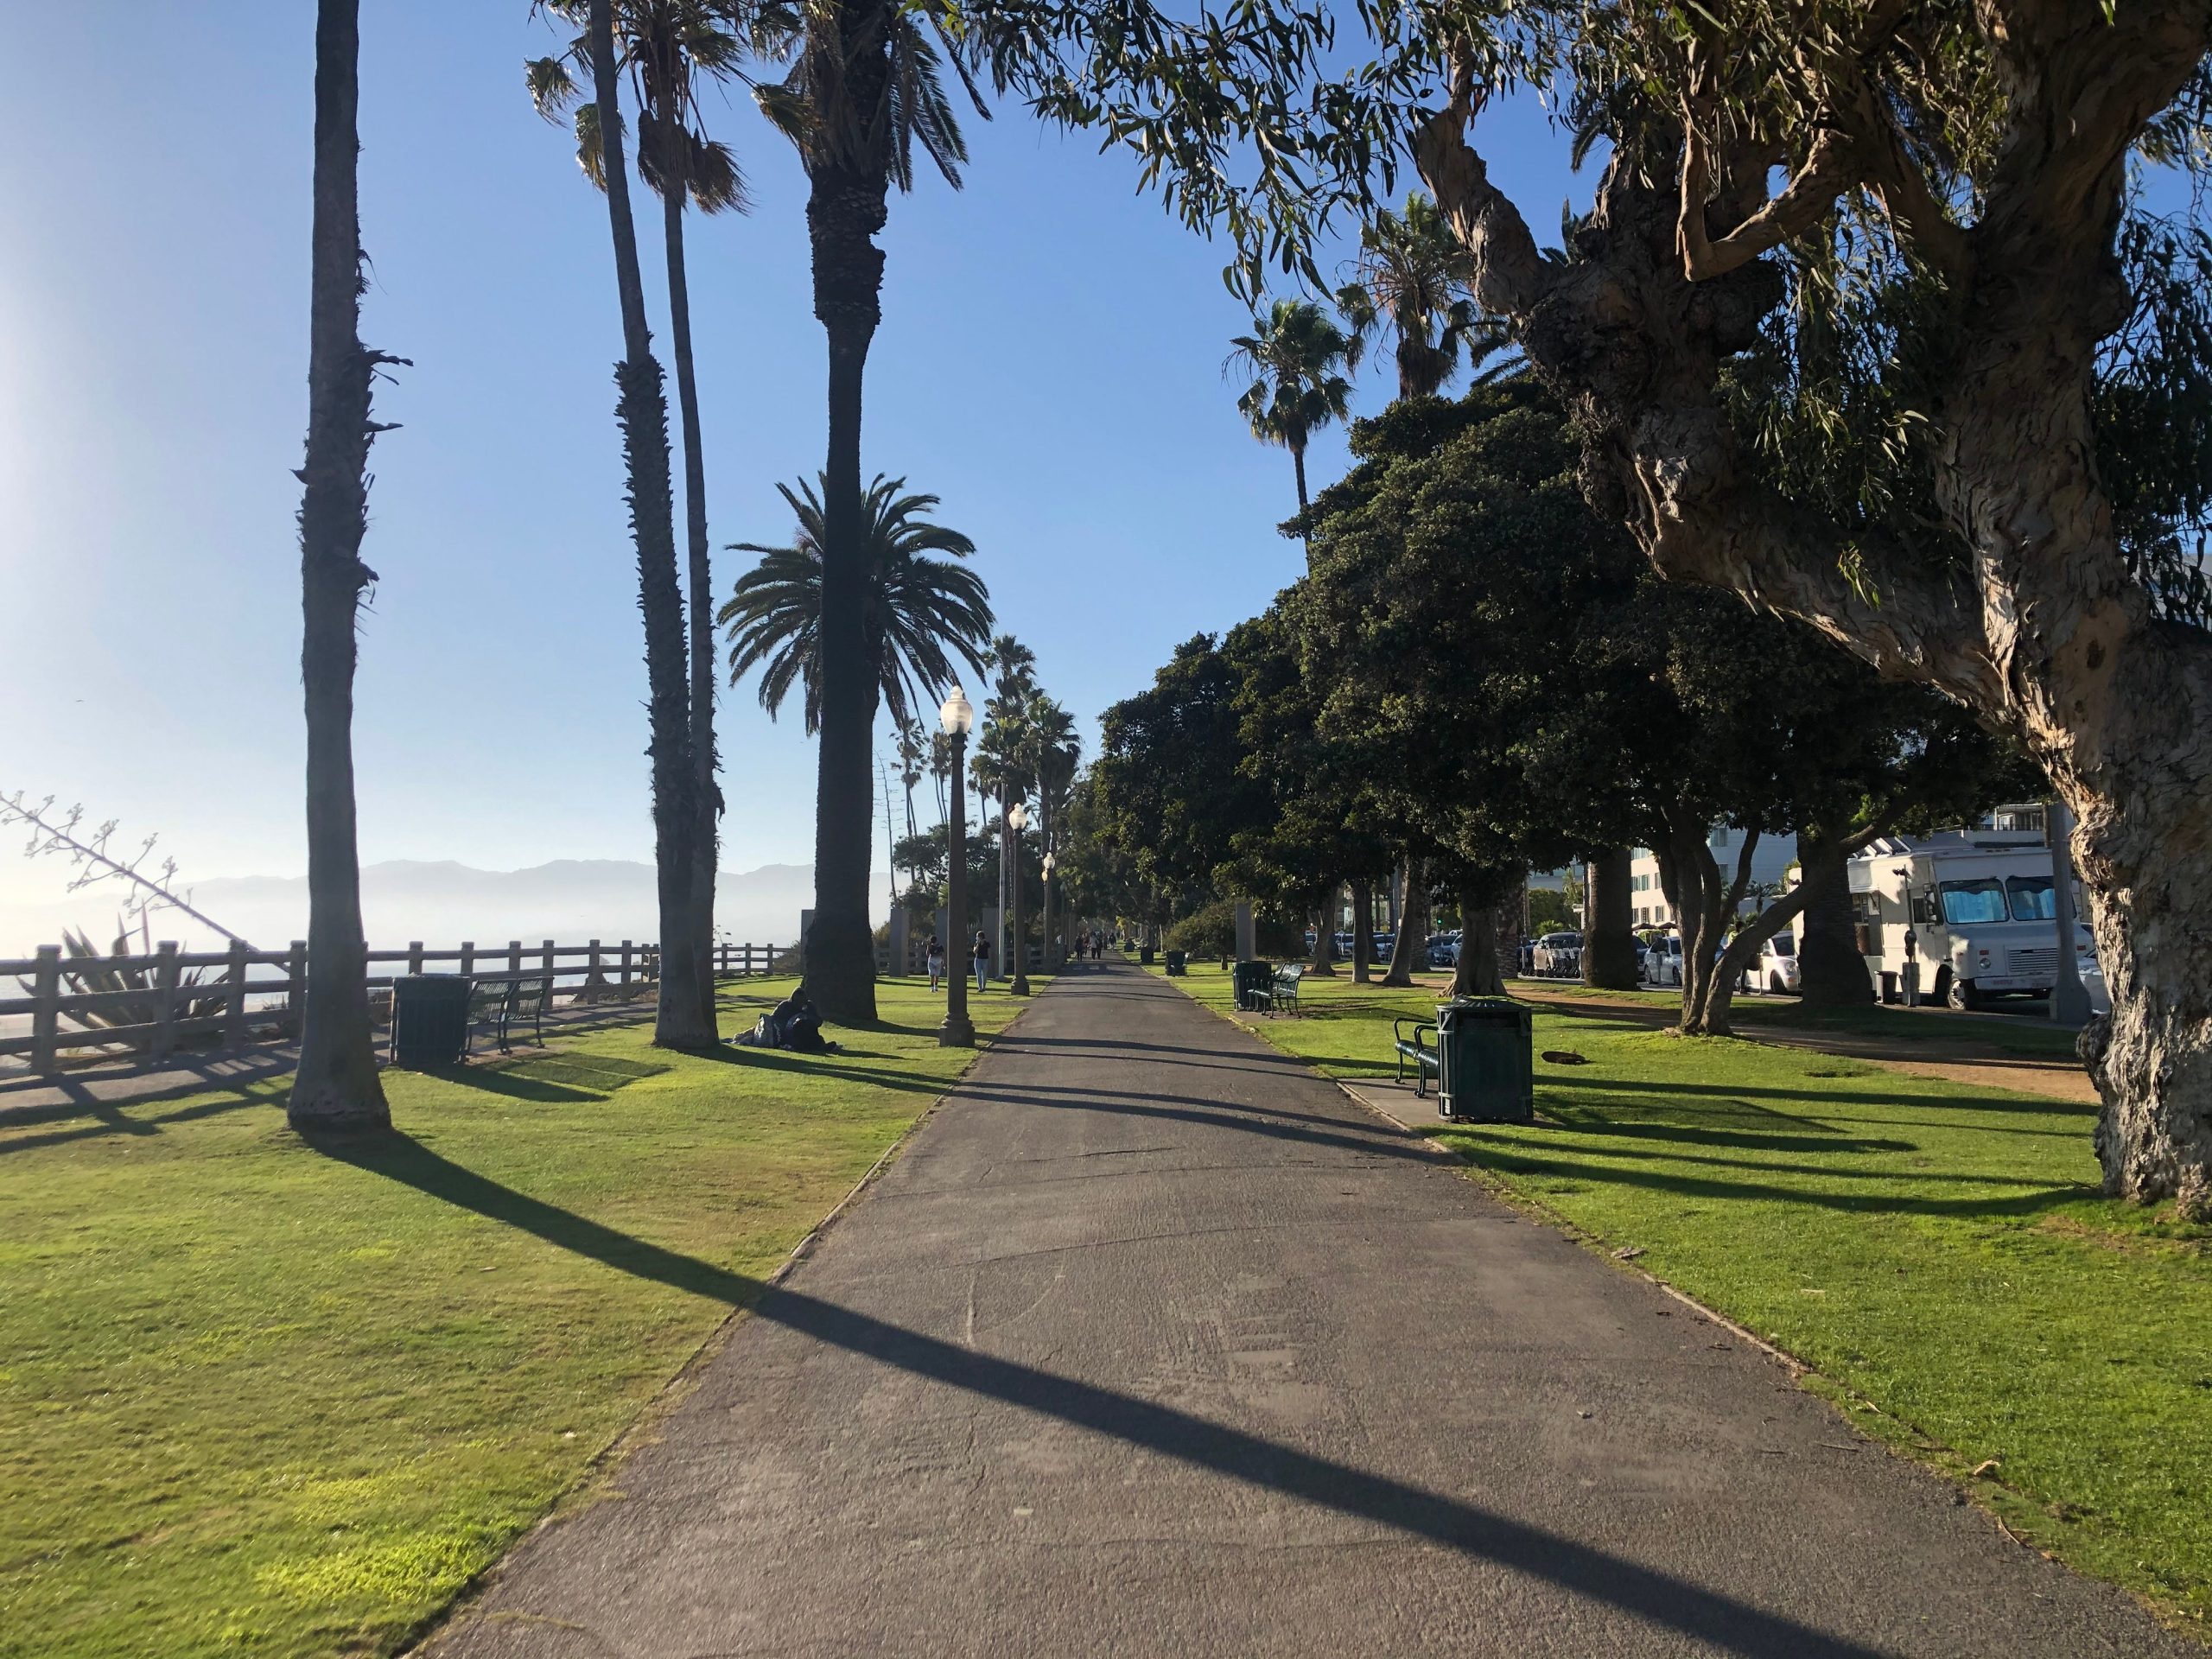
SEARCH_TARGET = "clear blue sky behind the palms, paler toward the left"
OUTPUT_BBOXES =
[0,0,1591,915]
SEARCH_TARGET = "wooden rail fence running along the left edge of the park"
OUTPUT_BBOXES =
[0,940,790,1071]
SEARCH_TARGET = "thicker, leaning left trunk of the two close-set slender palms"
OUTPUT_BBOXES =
[591,0,715,1048]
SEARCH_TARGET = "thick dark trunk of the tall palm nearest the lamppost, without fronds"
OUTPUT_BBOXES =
[807,145,889,1024]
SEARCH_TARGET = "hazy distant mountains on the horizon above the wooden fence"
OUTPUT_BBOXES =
[0,858,849,956]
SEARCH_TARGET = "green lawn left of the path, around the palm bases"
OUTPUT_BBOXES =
[0,980,1020,1659]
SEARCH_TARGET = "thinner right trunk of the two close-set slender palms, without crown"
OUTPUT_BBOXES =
[661,168,721,1039]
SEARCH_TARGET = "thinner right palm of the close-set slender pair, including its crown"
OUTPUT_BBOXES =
[524,0,759,1028]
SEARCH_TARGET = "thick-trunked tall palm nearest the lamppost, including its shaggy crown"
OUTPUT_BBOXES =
[757,0,982,1024]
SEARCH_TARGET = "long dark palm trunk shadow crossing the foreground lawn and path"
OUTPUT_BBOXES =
[316,1135,1878,1659]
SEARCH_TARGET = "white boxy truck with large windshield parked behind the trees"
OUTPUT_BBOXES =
[1852,830,2104,1008]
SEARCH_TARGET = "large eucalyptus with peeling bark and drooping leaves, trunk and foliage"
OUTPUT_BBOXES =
[976,0,2212,1210]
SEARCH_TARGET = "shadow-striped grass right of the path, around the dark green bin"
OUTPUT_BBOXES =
[1177,964,2212,1635]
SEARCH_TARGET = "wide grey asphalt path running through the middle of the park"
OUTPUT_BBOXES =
[431,964,2203,1659]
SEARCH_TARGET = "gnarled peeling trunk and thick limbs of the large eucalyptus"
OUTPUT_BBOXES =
[1415,29,2212,1212]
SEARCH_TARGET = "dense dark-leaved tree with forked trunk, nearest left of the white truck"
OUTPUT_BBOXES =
[1296,376,2004,1031]
